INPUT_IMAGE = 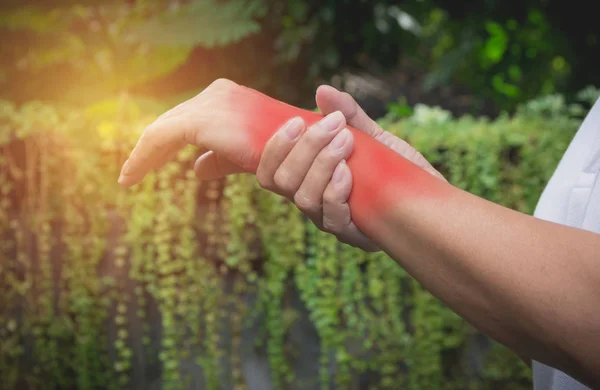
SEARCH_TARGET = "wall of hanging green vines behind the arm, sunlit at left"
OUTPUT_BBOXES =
[0,89,598,390]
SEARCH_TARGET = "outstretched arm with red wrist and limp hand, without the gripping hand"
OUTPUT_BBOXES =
[119,80,600,386]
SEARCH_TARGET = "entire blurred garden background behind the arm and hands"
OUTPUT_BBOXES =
[0,0,600,390]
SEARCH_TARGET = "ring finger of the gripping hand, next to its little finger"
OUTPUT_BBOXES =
[294,129,354,228]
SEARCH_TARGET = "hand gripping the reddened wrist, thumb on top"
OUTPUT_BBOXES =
[257,86,445,252]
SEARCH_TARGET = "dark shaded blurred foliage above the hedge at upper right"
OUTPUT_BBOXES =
[265,0,598,112]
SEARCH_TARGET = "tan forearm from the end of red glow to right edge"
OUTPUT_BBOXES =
[363,177,600,386]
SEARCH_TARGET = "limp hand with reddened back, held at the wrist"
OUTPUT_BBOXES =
[119,79,321,187]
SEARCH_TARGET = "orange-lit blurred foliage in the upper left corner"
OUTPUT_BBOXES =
[0,0,265,102]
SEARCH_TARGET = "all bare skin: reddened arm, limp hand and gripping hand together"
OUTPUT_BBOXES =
[120,81,600,387]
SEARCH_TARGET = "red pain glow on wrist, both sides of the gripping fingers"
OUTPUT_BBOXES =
[229,87,441,230]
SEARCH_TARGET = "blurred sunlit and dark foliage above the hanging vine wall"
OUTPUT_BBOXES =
[0,0,600,114]
